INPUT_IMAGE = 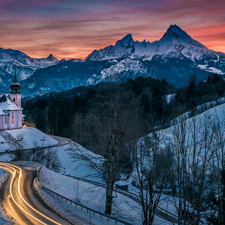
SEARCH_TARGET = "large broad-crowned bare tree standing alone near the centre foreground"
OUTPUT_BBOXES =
[67,83,144,214]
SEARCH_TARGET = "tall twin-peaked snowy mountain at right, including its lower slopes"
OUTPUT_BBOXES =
[86,25,225,86]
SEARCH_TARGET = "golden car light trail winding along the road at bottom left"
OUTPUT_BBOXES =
[0,163,64,225]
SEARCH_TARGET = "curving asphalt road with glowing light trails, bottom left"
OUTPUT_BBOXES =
[0,163,70,225]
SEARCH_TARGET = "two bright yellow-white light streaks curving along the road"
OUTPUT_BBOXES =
[2,163,61,225]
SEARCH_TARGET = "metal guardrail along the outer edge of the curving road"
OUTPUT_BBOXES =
[37,166,132,225]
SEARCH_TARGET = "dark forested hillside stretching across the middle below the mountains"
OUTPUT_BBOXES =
[23,74,225,153]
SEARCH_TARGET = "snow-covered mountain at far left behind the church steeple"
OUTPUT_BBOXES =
[0,48,58,91]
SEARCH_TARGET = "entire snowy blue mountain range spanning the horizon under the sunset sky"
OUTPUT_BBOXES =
[0,25,225,95]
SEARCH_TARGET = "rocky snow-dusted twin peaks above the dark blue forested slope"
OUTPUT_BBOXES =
[86,25,220,62]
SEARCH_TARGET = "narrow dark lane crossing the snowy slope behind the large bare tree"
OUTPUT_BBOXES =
[65,174,178,220]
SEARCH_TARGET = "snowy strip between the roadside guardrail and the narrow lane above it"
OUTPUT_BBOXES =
[39,167,170,225]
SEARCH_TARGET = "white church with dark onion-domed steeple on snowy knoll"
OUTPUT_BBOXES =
[0,71,23,130]
